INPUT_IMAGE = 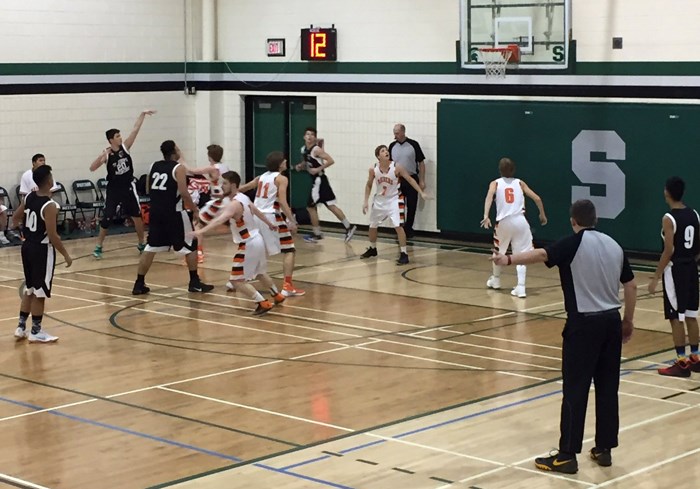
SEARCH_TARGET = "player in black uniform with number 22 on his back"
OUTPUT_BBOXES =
[131,140,214,295]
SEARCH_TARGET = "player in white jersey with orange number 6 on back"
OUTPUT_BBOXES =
[481,158,547,298]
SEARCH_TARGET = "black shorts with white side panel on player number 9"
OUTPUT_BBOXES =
[662,261,700,321]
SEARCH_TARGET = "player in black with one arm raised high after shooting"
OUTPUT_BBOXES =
[90,110,156,259]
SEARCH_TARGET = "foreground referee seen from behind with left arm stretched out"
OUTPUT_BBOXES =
[491,200,637,474]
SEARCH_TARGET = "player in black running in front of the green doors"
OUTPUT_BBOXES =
[295,127,357,243]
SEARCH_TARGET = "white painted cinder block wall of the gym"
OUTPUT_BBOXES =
[0,0,700,221]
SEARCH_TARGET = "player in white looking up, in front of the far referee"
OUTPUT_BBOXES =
[360,144,427,265]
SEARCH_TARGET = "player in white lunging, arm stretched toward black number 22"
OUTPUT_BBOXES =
[193,171,285,316]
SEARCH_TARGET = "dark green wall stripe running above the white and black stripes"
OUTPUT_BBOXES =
[0,61,700,76]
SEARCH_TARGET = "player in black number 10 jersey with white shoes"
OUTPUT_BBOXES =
[12,165,73,343]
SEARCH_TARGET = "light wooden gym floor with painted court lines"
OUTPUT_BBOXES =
[0,230,700,489]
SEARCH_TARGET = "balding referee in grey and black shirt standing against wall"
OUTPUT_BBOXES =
[389,124,425,238]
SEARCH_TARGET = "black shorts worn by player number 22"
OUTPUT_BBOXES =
[146,211,197,255]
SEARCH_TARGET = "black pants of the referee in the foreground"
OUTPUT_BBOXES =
[559,311,622,454]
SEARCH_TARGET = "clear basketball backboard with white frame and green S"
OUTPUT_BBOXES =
[460,0,571,70]
